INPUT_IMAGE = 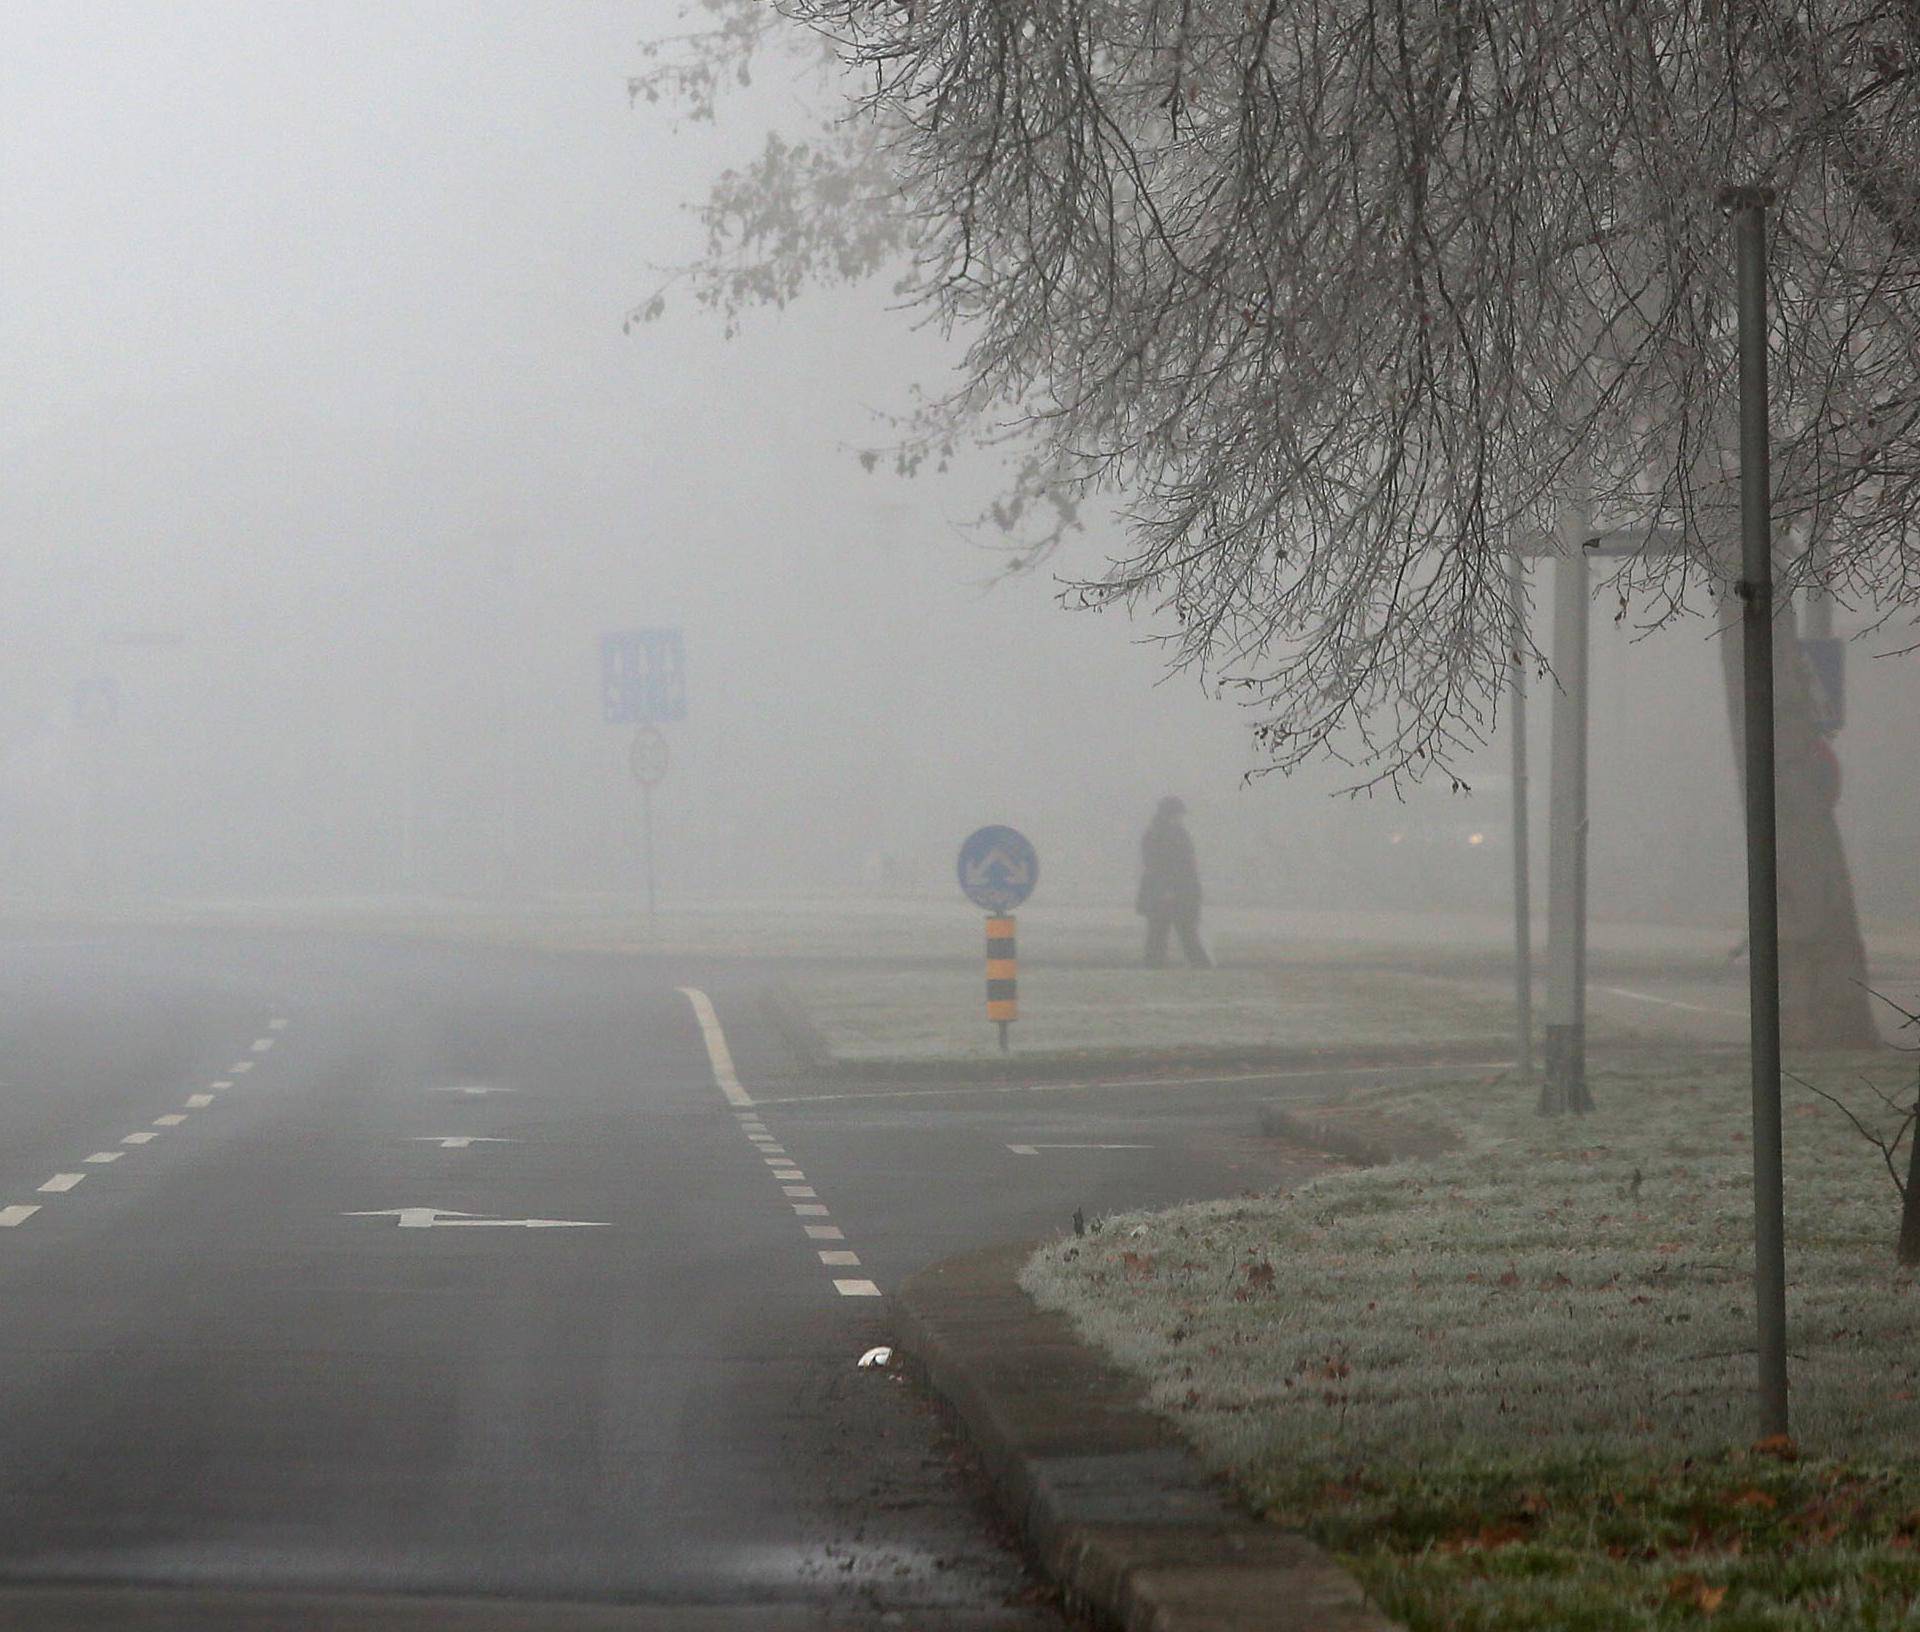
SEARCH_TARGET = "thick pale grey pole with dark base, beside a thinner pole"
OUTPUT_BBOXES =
[1540,526,1594,1116]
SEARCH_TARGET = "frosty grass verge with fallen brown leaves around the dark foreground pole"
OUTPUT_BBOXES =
[1023,1056,1920,1628]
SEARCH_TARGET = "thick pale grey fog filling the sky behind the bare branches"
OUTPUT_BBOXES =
[0,0,1920,922]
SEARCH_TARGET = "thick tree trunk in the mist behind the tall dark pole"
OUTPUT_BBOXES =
[1720,593,1880,1048]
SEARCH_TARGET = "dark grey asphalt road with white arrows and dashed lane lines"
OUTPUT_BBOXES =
[0,933,1328,1628]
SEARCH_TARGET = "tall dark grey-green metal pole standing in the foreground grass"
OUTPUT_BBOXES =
[1722,188,1788,1436]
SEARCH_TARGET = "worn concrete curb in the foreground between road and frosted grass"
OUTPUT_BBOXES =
[891,1246,1398,1632]
